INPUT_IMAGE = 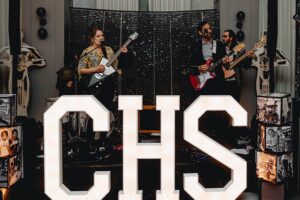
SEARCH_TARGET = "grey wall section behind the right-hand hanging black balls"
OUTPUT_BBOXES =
[220,0,267,125]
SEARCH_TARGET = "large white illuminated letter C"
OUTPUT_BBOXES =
[44,95,111,200]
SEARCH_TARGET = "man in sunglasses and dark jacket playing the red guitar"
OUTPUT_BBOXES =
[188,21,227,99]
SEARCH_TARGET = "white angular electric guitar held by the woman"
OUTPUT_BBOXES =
[86,32,138,90]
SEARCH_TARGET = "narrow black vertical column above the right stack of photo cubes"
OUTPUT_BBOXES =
[267,0,278,92]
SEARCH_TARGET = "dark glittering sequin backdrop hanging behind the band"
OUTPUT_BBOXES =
[69,8,220,107]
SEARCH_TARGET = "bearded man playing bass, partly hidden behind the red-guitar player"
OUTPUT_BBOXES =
[222,30,253,102]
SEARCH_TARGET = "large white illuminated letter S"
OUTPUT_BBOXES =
[184,95,247,200]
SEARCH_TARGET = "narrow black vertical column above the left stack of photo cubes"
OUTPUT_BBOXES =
[9,0,21,94]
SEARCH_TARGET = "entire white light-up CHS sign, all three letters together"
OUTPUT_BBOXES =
[44,96,247,200]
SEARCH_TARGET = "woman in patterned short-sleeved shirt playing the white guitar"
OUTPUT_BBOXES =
[78,27,128,111]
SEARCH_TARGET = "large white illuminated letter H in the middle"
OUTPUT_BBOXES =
[119,96,179,200]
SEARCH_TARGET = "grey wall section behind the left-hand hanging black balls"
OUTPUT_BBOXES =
[22,0,64,120]
